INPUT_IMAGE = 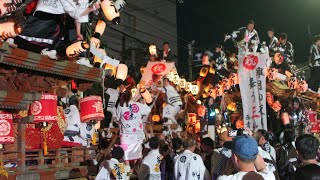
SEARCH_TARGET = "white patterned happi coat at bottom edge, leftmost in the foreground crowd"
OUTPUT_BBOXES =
[96,158,131,180]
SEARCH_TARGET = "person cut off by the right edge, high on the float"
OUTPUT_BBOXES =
[309,35,320,92]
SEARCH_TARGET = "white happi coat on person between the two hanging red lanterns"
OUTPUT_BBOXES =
[63,105,94,146]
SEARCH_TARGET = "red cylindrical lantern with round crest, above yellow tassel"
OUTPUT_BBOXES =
[29,93,58,123]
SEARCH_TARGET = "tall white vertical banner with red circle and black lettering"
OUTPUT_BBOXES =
[238,54,269,131]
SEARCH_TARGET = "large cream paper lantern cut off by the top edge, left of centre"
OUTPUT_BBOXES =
[100,0,120,24]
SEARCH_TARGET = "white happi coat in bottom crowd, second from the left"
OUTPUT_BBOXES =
[142,149,163,180]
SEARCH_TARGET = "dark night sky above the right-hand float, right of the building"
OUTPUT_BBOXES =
[177,0,320,70]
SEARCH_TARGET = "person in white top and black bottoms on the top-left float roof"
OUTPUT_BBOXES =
[14,0,100,61]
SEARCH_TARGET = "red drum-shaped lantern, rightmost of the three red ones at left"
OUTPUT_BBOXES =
[80,96,104,122]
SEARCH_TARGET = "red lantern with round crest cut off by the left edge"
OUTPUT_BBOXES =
[0,111,14,144]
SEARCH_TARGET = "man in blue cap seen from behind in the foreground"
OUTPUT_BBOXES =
[218,135,275,180]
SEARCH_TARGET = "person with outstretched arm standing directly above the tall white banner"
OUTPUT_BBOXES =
[224,20,260,52]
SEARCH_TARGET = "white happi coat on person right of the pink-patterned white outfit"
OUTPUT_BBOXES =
[159,85,182,121]
